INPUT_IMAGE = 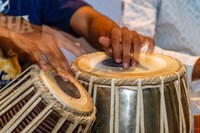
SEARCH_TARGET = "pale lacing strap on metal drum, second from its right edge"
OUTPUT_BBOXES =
[174,72,186,133]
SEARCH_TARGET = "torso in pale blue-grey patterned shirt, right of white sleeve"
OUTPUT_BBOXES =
[156,0,200,55]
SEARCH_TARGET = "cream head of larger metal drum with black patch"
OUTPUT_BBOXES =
[72,52,181,79]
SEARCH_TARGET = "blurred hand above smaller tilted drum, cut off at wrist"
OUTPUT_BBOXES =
[10,26,82,73]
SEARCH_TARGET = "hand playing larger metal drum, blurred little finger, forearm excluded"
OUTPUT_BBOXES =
[99,27,155,69]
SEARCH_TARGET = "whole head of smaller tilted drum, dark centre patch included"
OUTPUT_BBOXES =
[40,71,94,114]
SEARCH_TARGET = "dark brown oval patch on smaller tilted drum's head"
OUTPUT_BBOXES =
[55,75,81,99]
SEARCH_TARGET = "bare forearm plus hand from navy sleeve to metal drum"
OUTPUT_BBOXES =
[70,6,150,68]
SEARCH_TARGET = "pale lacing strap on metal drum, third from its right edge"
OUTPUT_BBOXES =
[159,76,169,133]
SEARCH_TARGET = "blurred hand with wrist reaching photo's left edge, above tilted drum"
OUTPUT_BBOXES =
[0,16,82,73]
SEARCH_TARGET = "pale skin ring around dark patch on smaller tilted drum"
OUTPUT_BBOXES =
[39,71,94,115]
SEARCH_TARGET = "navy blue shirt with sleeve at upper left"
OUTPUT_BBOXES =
[0,0,88,35]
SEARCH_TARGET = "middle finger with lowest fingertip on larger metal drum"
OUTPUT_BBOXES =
[122,27,131,69]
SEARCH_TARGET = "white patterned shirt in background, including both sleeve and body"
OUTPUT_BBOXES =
[123,0,200,55]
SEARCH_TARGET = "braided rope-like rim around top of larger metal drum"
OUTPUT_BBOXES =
[71,52,186,86]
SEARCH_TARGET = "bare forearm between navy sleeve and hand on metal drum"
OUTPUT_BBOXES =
[70,7,118,48]
